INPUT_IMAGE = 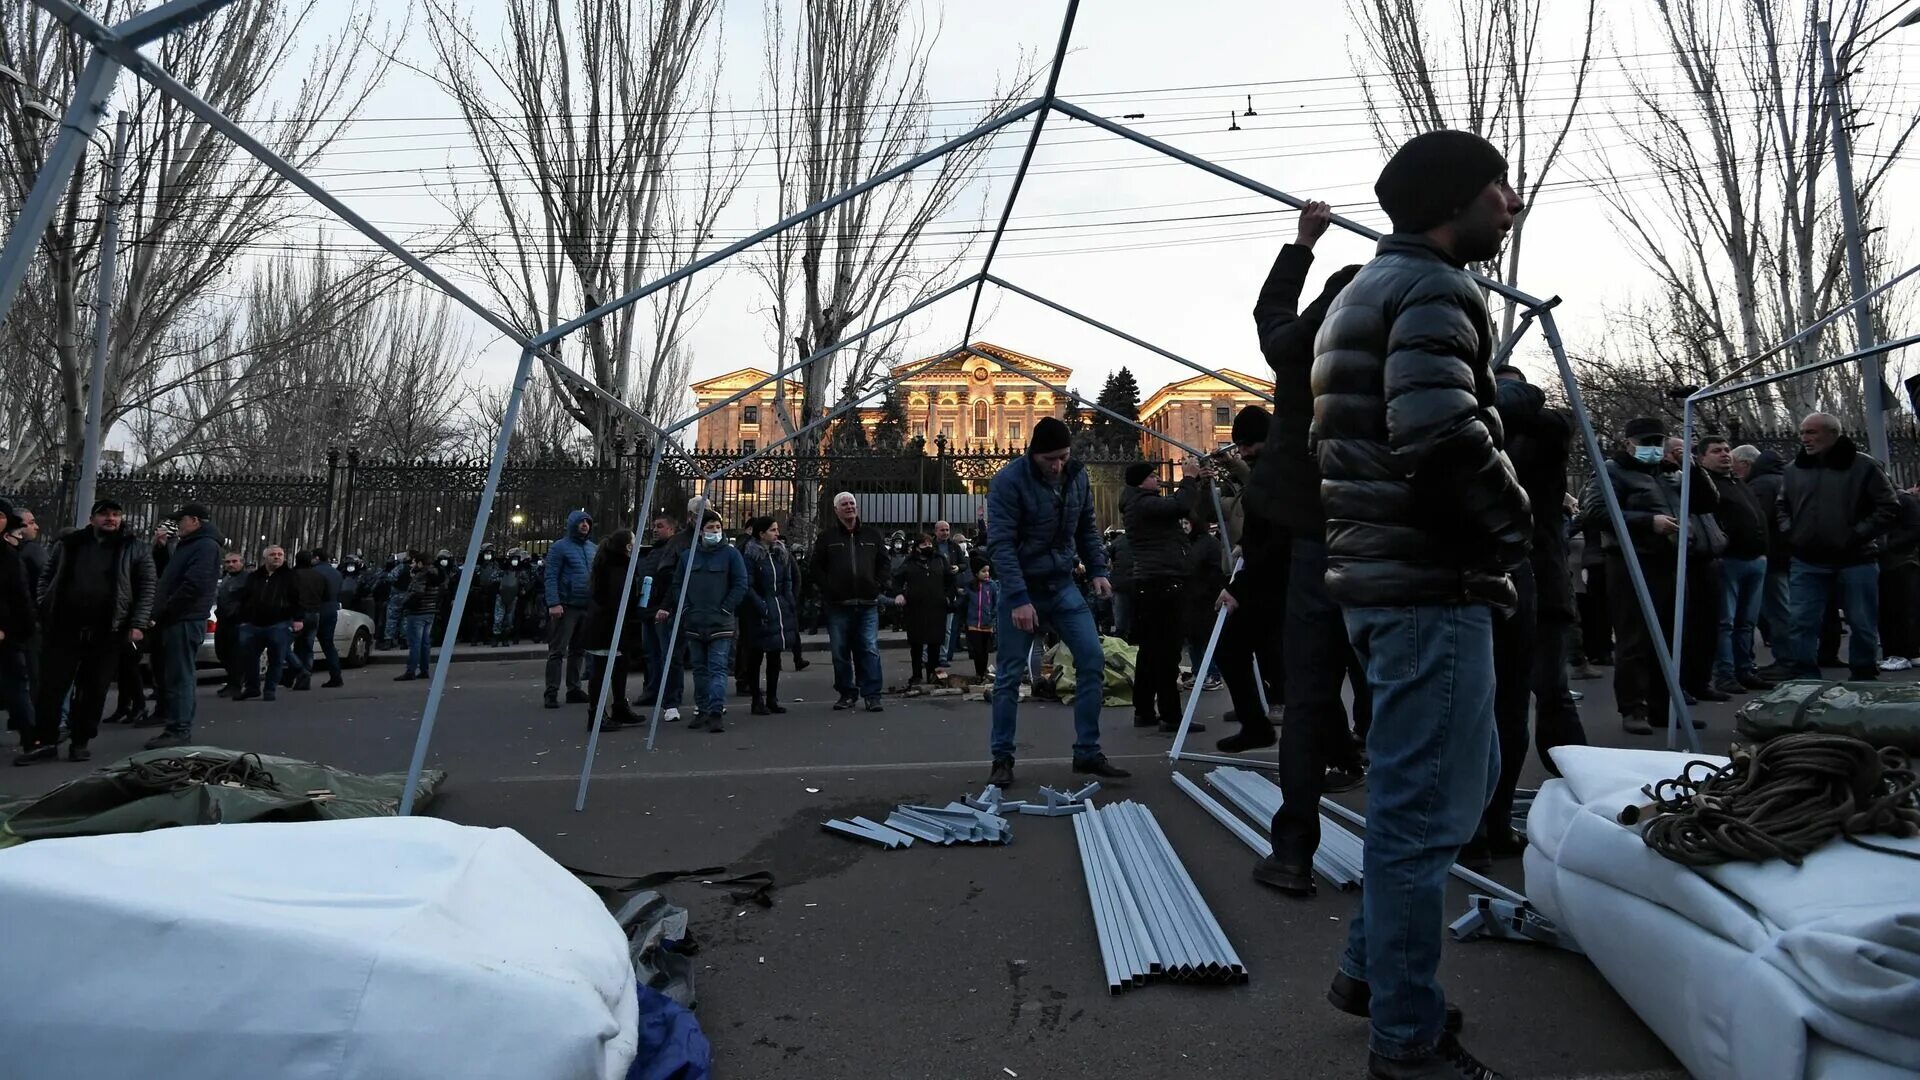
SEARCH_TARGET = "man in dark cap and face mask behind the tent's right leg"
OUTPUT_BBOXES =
[1580,409,1720,734]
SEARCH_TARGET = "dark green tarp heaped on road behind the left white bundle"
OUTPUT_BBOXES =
[0,746,447,847]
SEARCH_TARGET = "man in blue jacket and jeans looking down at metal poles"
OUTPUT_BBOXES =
[987,417,1131,790]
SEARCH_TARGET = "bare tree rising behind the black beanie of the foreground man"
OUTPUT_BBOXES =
[1348,0,1599,334]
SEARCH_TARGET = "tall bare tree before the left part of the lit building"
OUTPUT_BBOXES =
[753,0,1033,523]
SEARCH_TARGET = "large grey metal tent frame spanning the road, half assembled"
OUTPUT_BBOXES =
[0,0,1693,815]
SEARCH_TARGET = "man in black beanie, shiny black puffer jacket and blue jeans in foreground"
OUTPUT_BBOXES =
[1311,131,1532,1080]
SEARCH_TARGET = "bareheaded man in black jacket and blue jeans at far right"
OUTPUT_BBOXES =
[1774,413,1899,680]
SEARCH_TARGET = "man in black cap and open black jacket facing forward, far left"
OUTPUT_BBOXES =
[13,500,154,765]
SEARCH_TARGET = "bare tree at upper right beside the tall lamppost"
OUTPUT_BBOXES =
[1594,0,1920,427]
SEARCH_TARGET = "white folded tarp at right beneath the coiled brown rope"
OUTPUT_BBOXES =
[1526,746,1920,1080]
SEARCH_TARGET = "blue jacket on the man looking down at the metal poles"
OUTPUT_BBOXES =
[987,454,1113,607]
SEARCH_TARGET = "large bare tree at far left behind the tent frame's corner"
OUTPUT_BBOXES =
[0,0,399,480]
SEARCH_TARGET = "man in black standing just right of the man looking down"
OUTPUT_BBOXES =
[1121,453,1200,734]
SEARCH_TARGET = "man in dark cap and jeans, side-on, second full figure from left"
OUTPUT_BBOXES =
[146,503,221,749]
